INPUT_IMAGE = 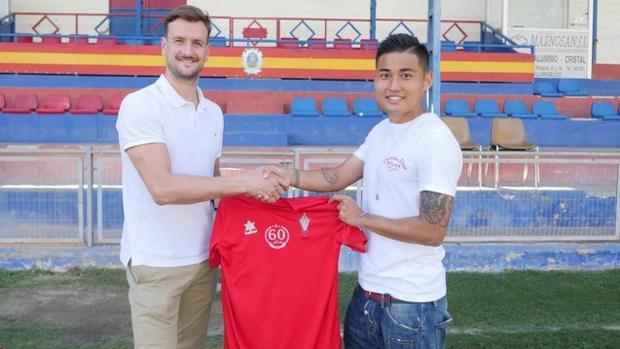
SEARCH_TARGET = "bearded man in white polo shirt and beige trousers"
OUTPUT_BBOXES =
[116,6,288,349]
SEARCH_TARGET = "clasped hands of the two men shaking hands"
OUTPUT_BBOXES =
[244,165,298,203]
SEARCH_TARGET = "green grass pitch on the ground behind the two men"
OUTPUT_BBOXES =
[0,269,620,349]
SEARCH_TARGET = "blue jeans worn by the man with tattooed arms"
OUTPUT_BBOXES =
[344,285,452,349]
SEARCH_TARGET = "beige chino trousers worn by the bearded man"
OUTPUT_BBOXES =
[127,261,217,349]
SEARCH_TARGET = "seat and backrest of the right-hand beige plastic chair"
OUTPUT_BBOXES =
[491,118,538,150]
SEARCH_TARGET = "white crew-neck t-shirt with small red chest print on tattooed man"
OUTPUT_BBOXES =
[354,113,462,302]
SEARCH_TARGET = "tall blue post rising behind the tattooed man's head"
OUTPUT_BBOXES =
[426,0,441,115]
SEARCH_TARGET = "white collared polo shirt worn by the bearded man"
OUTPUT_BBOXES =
[116,75,224,267]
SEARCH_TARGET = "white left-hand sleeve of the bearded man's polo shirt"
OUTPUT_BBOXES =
[116,93,166,151]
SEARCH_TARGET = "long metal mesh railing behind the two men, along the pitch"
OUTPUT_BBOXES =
[0,145,620,242]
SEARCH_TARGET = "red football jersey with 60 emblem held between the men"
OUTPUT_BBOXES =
[209,196,366,349]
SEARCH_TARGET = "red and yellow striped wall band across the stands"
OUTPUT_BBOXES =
[0,43,534,82]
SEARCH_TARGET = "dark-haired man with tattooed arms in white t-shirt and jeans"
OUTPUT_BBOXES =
[265,34,462,349]
